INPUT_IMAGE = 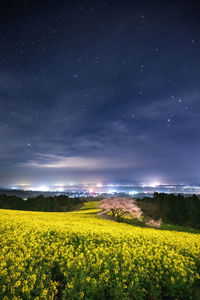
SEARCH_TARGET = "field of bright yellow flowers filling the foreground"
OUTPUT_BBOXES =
[0,204,200,300]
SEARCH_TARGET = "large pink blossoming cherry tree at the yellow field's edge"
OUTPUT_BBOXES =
[99,197,142,220]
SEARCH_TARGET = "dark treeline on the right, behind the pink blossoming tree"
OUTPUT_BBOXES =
[137,193,200,228]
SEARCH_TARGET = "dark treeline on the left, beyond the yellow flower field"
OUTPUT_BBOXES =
[0,195,83,212]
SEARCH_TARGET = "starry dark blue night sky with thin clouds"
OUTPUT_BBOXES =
[0,0,200,186]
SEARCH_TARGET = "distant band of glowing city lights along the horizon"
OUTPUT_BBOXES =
[0,182,200,199]
